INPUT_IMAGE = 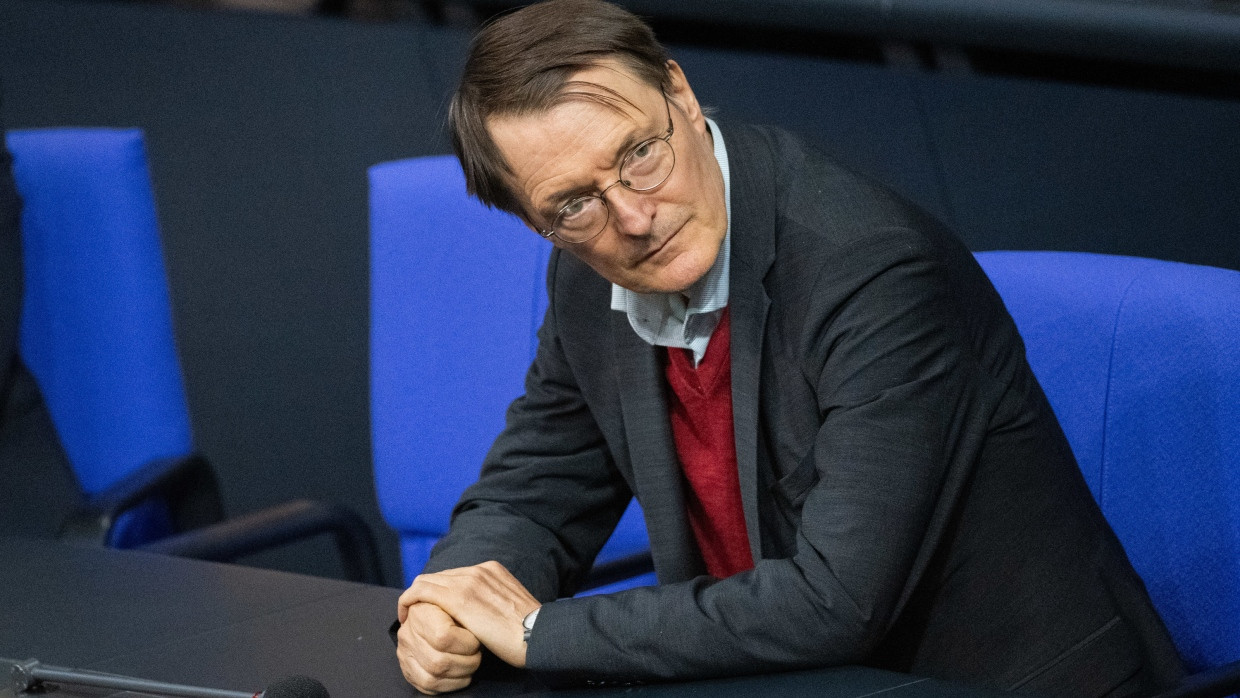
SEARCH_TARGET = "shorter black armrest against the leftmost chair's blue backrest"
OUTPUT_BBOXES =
[60,454,223,546]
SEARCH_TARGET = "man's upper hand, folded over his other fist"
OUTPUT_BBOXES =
[398,562,541,669]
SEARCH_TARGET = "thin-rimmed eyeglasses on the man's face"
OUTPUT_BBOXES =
[538,94,676,243]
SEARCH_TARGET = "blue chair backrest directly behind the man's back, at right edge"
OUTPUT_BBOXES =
[977,252,1240,671]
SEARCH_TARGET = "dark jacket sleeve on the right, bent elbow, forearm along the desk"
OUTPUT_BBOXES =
[527,229,993,683]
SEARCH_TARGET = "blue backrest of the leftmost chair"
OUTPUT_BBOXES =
[6,129,192,543]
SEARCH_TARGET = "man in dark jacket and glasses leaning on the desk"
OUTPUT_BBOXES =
[398,0,1180,696]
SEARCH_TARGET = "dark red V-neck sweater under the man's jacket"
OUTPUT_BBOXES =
[667,309,754,578]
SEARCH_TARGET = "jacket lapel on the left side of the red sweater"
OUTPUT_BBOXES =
[610,312,706,584]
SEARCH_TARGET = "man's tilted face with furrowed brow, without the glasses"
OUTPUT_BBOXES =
[489,61,728,293]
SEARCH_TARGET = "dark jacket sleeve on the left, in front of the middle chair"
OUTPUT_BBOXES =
[425,252,632,601]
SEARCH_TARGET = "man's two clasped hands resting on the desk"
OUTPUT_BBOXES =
[397,562,539,694]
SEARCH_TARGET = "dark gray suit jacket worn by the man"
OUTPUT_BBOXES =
[428,125,1180,696]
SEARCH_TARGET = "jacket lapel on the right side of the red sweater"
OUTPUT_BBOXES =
[720,128,775,562]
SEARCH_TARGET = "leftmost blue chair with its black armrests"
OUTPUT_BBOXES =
[6,129,381,583]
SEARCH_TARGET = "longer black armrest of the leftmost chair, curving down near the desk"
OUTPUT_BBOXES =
[139,500,383,584]
